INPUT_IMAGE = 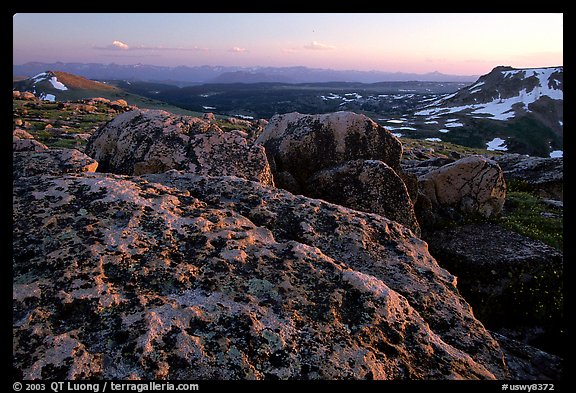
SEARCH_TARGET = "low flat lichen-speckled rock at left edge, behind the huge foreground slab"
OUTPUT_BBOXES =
[12,147,98,179]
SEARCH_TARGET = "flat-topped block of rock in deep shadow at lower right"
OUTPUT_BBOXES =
[424,224,565,352]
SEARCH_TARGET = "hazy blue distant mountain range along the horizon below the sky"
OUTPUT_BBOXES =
[12,62,478,86]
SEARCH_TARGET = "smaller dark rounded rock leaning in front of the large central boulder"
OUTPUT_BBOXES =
[306,160,420,234]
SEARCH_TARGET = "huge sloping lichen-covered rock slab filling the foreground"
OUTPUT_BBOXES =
[13,171,507,379]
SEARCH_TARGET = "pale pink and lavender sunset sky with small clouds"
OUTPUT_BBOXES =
[13,13,563,75]
